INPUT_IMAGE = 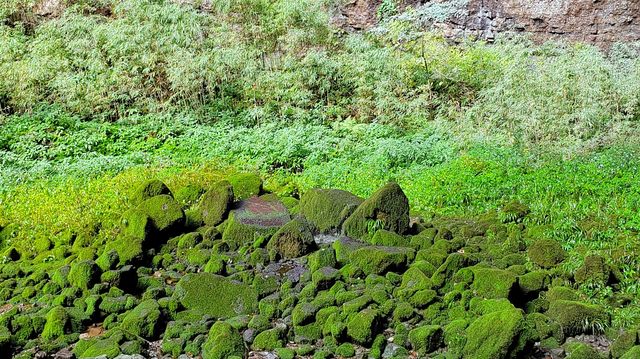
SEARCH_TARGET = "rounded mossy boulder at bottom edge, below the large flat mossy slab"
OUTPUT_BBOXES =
[202,322,245,359]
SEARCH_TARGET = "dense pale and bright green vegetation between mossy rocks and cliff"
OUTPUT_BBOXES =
[0,0,640,358]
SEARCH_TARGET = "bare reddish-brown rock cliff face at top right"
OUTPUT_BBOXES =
[340,0,640,47]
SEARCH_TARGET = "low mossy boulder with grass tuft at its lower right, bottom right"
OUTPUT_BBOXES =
[546,300,610,336]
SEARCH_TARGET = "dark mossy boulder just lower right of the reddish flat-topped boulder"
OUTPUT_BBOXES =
[267,218,316,259]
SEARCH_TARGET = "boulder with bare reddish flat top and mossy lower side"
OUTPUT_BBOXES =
[222,196,291,250]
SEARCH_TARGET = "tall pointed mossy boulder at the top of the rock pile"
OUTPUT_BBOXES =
[343,182,409,238]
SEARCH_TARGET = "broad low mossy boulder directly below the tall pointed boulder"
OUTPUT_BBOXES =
[350,246,414,275]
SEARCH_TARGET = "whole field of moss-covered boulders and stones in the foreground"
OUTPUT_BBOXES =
[0,174,640,359]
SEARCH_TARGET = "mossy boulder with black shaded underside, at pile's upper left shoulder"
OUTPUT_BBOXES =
[138,195,185,236]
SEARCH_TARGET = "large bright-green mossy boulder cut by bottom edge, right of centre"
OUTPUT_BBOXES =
[463,309,532,359]
